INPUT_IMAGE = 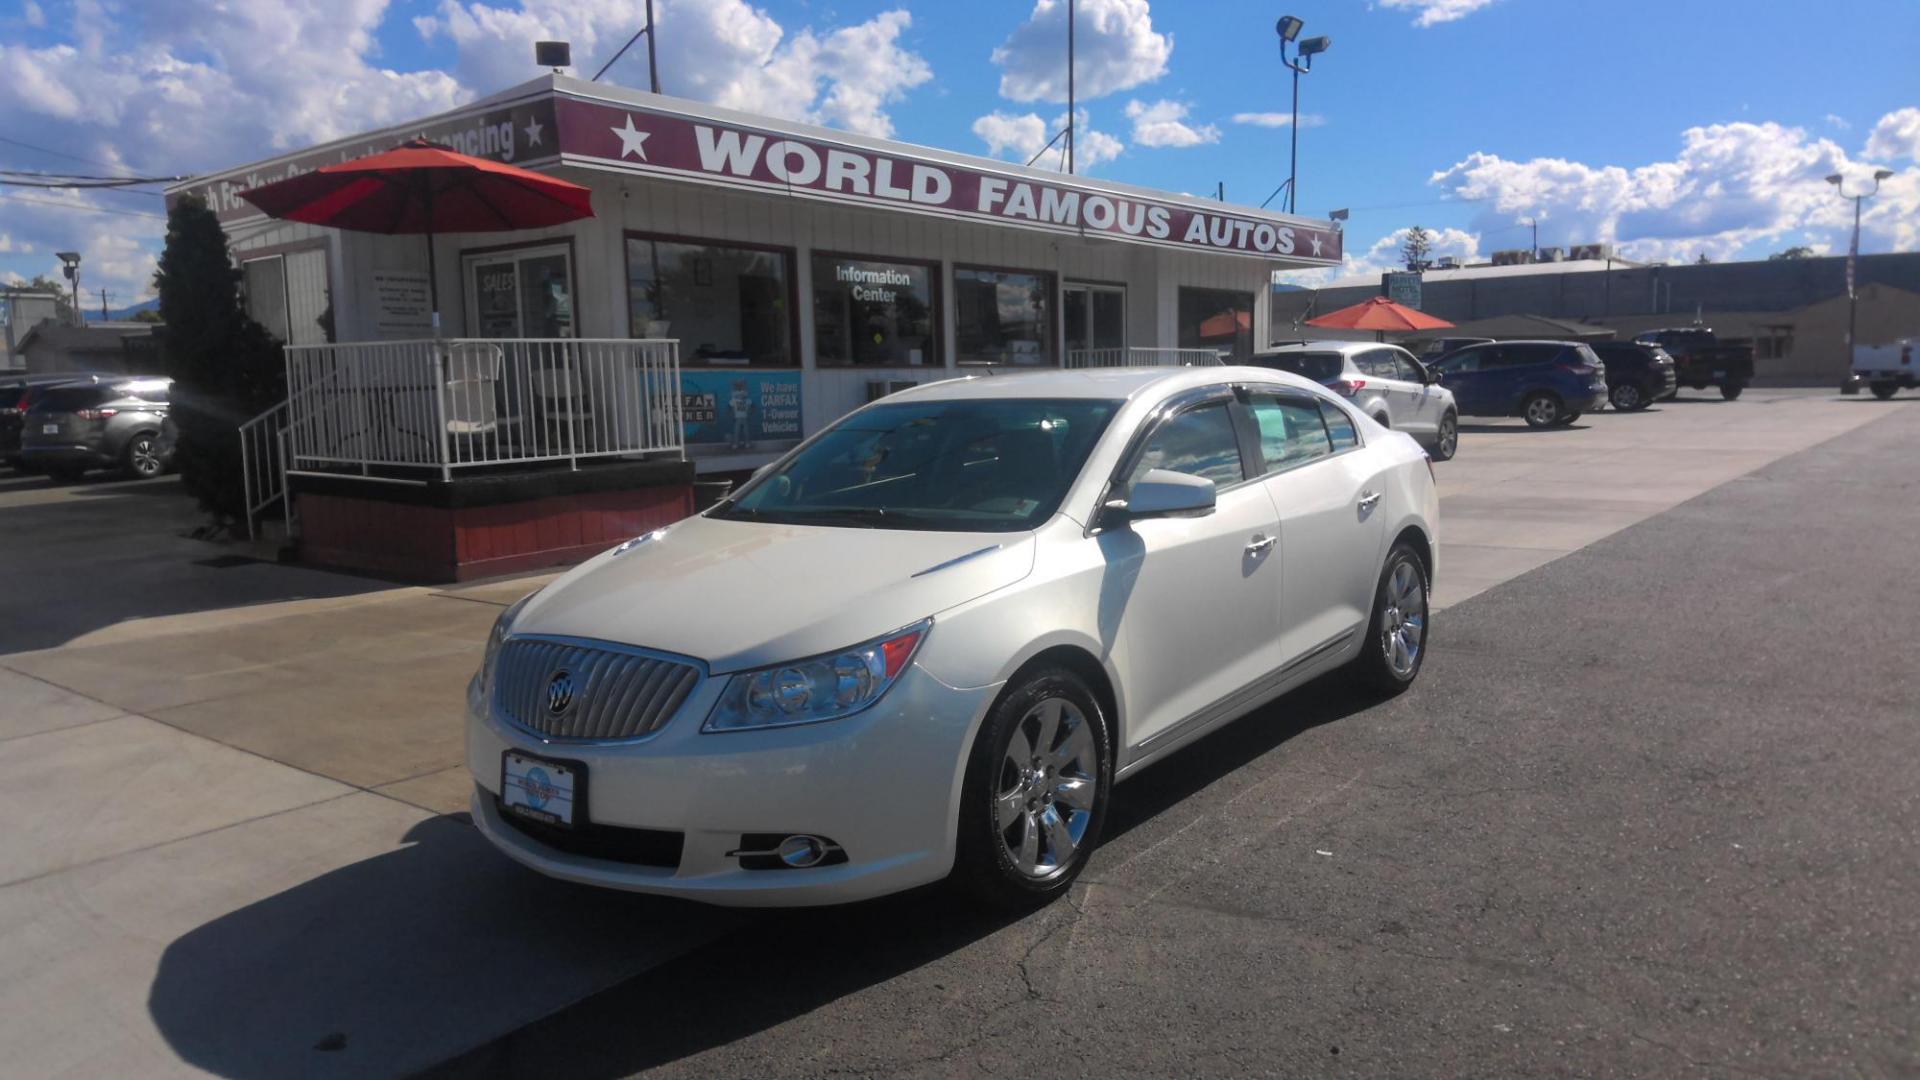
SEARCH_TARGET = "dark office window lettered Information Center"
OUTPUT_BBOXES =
[812,256,941,367]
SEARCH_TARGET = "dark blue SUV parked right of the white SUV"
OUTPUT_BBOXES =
[1432,342,1607,427]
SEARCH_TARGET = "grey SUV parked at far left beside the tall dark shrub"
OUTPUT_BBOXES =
[21,375,173,480]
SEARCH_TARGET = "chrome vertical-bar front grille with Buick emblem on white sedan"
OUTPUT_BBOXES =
[493,638,701,742]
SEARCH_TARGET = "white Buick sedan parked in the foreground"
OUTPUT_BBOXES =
[467,367,1438,905]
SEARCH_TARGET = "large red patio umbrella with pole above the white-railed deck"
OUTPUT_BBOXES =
[240,138,593,334]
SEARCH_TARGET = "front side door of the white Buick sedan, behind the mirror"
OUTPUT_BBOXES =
[1098,386,1281,746]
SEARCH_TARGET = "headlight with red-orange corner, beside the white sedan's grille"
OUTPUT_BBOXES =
[701,619,933,732]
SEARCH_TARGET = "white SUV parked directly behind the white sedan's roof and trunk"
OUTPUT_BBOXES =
[1246,342,1459,461]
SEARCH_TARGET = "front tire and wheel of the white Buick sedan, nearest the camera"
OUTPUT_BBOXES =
[954,665,1114,909]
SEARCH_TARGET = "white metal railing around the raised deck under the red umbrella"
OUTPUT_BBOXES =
[286,338,685,479]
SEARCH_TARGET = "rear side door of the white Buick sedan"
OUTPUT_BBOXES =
[1246,388,1386,669]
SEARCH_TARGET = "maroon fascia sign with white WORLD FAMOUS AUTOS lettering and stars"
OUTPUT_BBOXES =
[555,96,1340,265]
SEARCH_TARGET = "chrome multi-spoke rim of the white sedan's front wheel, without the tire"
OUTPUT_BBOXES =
[993,698,1100,878]
